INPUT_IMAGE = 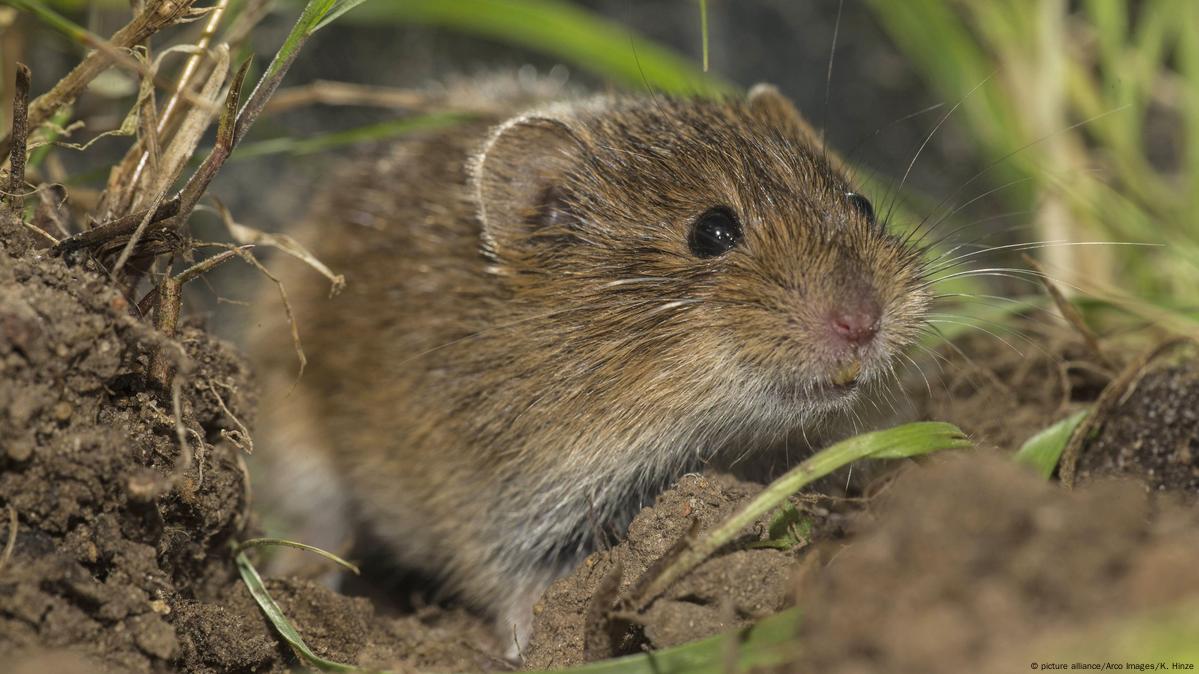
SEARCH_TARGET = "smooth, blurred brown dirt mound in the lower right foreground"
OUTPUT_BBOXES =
[799,455,1199,673]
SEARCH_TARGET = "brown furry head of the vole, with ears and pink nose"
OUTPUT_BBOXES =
[474,86,930,417]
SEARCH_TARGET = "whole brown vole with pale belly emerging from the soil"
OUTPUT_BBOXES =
[250,76,930,644]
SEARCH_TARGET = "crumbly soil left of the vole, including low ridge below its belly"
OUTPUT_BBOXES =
[0,242,507,673]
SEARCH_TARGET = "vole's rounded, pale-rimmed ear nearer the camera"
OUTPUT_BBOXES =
[472,116,583,254]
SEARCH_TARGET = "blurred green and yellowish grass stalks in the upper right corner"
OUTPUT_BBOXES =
[869,0,1199,331]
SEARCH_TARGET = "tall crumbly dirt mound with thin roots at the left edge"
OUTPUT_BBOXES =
[0,243,252,672]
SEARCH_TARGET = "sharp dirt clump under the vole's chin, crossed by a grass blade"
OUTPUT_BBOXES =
[525,467,850,669]
